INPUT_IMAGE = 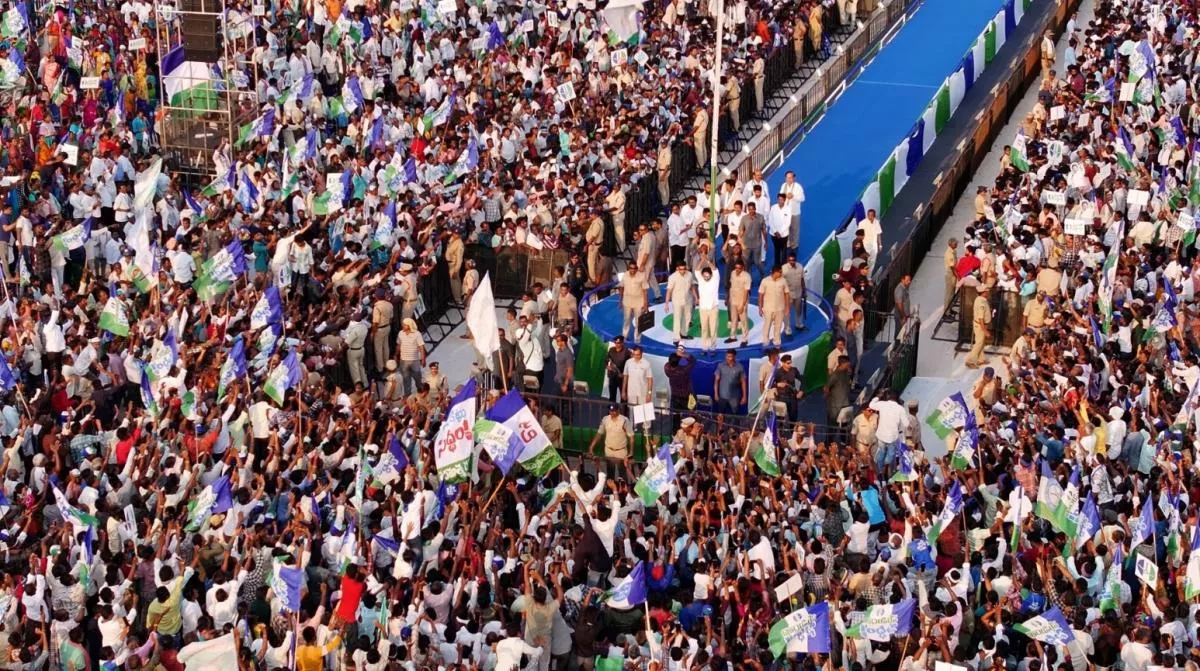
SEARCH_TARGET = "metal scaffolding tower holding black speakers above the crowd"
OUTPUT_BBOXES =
[155,0,259,181]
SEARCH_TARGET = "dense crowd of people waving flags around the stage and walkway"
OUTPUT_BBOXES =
[0,0,1200,671]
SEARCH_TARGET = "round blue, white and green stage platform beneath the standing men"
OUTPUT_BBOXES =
[575,283,833,412]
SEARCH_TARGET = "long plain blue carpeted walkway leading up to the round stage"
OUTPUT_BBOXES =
[767,0,1003,259]
